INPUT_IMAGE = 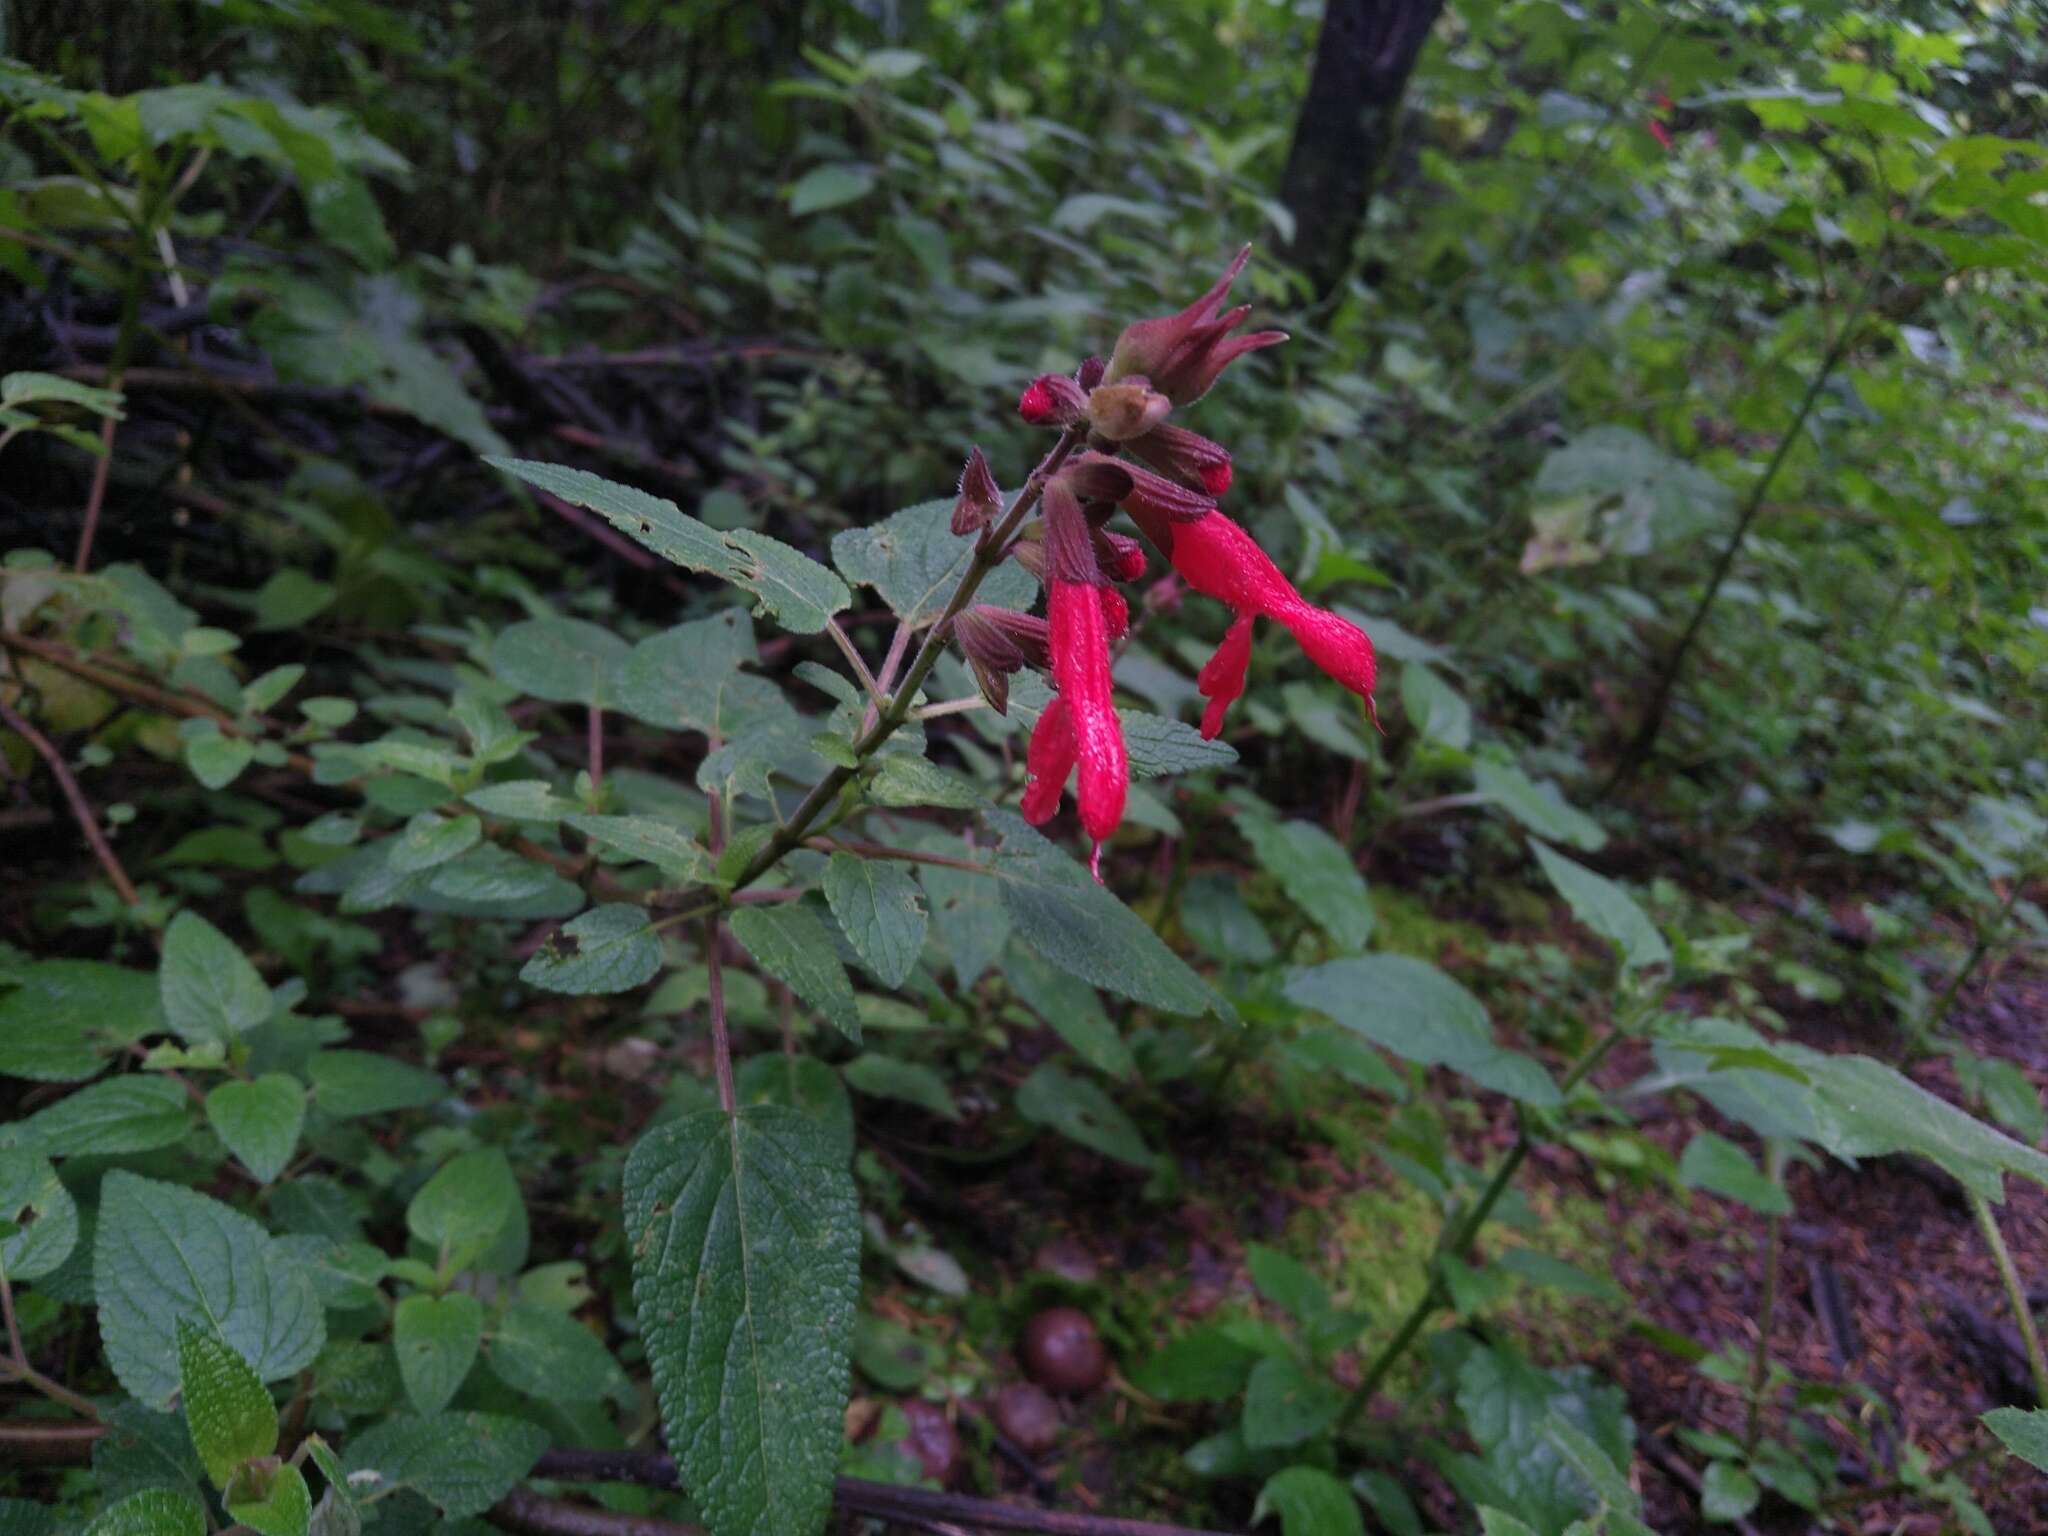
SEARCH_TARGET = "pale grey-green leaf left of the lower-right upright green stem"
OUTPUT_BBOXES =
[1286,954,1559,1106]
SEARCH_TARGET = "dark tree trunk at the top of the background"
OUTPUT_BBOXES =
[1280,0,1444,293]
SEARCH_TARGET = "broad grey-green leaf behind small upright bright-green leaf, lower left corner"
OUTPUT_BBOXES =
[92,1169,326,1407]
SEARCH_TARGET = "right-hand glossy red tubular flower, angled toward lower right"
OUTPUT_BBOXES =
[1124,505,1378,737]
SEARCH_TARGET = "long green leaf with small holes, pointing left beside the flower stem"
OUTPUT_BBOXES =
[485,459,854,635]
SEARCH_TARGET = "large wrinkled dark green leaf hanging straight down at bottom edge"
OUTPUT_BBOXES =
[625,1106,860,1536]
